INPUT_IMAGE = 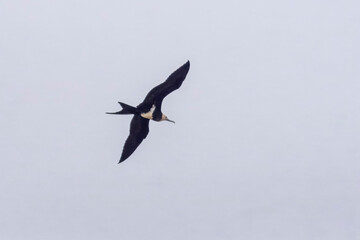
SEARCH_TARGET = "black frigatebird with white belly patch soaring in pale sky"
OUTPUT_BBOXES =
[107,61,190,163]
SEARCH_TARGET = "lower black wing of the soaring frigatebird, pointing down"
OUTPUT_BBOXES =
[119,114,149,163]
